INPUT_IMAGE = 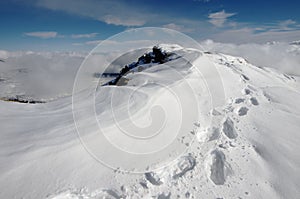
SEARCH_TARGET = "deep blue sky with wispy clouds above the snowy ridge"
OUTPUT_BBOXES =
[0,0,300,51]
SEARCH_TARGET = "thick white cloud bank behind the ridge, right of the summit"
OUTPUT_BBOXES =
[201,39,300,76]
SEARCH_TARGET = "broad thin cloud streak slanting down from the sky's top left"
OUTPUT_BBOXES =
[36,0,149,26]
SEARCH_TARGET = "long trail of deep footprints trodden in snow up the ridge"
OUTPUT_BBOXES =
[51,54,286,199]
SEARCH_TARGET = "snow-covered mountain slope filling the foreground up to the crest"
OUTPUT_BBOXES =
[0,45,300,199]
